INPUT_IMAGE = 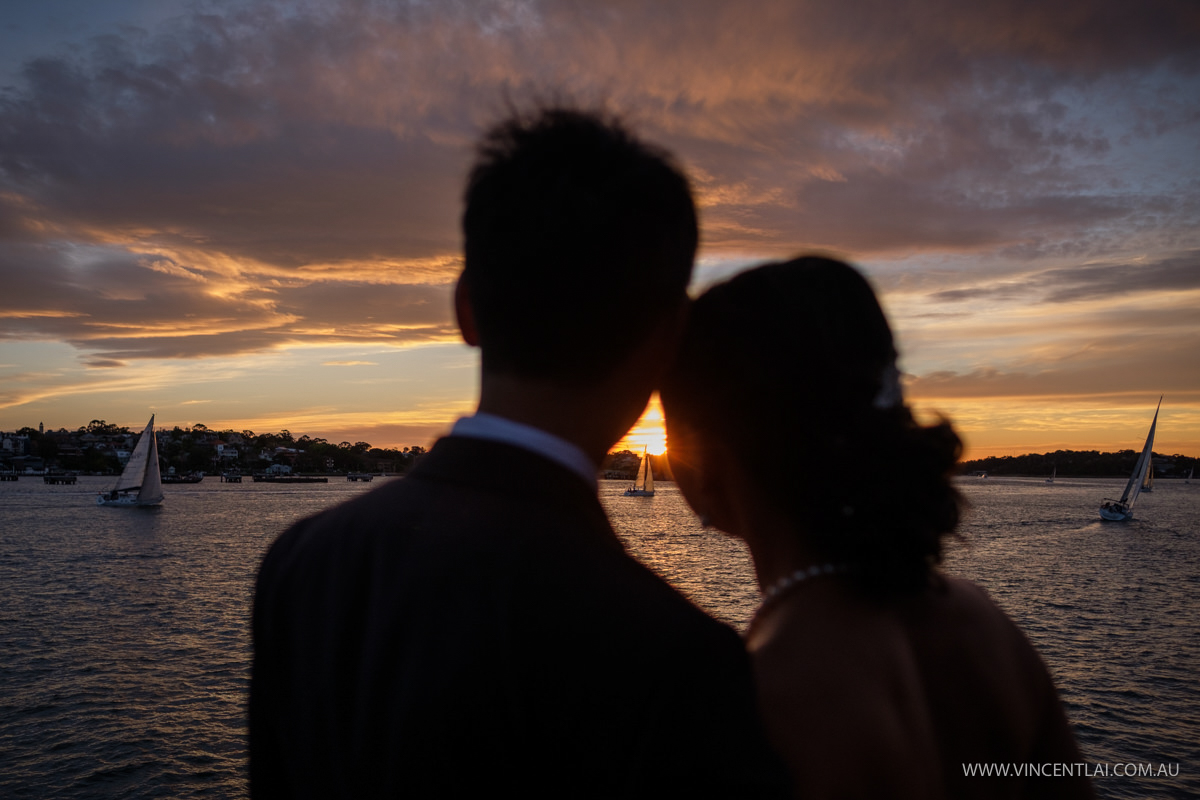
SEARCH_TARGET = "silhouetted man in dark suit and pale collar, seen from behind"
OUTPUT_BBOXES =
[250,108,787,799]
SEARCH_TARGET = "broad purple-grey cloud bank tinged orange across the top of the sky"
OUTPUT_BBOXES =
[0,0,1200,267]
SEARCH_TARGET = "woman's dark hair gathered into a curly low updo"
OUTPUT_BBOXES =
[661,257,961,591]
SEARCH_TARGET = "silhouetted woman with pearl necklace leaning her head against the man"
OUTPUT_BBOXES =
[662,257,1092,799]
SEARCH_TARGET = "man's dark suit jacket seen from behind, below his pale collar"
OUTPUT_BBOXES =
[250,438,787,799]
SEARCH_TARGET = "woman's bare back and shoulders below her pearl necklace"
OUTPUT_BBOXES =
[749,577,1078,796]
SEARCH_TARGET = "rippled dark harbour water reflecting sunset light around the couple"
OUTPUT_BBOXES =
[0,477,1200,799]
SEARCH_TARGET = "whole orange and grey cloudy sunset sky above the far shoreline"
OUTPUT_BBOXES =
[0,0,1200,457]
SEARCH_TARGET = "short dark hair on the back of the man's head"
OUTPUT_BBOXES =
[462,107,698,381]
